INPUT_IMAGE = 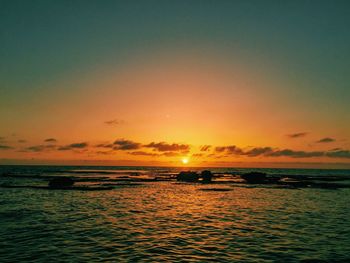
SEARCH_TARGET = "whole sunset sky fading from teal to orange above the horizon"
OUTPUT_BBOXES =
[0,0,350,168]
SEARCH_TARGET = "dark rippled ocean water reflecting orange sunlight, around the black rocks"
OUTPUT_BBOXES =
[0,166,350,262]
